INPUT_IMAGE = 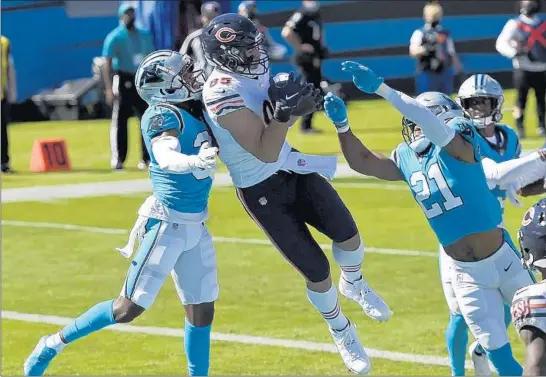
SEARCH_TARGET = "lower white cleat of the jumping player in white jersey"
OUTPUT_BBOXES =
[330,322,372,374]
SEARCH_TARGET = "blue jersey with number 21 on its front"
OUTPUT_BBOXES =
[392,119,502,247]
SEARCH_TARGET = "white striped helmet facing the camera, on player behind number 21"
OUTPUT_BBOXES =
[457,73,504,128]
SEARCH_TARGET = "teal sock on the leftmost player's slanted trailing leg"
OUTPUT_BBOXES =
[61,300,116,343]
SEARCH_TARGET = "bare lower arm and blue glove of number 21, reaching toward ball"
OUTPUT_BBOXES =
[324,93,404,181]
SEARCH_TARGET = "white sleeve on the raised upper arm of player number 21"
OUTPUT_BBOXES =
[377,84,455,148]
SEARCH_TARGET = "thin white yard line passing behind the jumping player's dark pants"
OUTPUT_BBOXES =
[2,220,438,258]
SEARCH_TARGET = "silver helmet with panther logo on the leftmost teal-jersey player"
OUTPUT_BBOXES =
[135,50,205,104]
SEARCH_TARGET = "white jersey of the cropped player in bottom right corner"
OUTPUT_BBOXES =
[512,280,546,333]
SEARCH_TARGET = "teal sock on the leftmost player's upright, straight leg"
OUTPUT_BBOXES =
[184,318,211,376]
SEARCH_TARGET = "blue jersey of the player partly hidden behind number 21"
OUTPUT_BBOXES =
[480,124,521,211]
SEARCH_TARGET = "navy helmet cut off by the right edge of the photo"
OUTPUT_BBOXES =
[518,198,546,269]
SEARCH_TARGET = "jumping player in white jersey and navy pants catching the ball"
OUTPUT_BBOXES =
[201,14,392,374]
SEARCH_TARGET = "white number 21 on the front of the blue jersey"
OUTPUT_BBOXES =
[410,164,463,219]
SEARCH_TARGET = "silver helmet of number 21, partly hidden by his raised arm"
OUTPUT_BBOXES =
[402,92,464,153]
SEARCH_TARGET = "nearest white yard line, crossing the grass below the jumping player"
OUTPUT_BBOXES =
[2,310,472,369]
